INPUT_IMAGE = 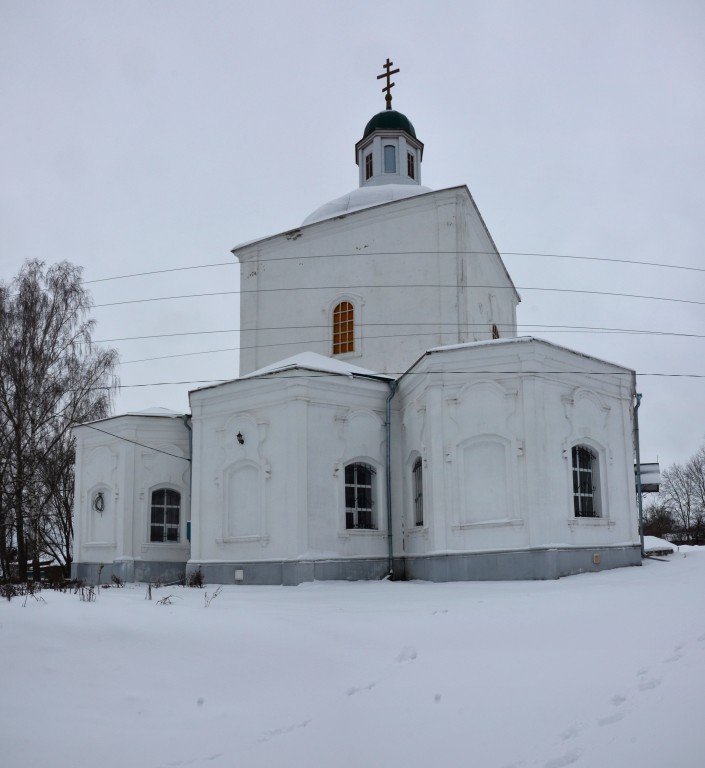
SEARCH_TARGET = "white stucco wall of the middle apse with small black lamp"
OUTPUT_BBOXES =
[191,371,389,563]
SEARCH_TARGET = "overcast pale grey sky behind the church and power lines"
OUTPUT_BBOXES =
[0,0,705,466]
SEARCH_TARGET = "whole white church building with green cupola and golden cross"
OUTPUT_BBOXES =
[73,62,641,584]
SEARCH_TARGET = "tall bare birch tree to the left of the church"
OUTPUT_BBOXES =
[0,261,117,579]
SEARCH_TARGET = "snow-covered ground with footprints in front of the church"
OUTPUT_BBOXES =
[0,548,705,768]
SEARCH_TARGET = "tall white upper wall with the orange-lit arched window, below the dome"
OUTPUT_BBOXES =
[233,187,518,375]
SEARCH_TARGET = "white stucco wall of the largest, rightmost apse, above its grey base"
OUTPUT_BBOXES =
[398,339,638,554]
